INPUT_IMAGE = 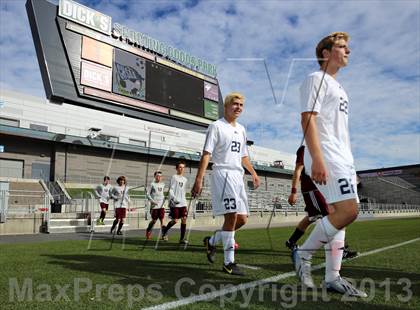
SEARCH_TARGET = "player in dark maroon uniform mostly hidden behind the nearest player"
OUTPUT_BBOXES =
[286,145,358,258]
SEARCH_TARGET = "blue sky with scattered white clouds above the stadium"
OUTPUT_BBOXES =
[0,0,420,170]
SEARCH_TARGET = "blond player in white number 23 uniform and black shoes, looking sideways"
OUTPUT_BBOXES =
[192,93,260,275]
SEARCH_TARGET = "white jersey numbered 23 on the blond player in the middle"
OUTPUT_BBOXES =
[204,118,248,173]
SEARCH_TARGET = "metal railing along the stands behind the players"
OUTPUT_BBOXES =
[0,189,420,232]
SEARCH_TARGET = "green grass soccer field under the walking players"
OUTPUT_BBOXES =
[0,218,420,310]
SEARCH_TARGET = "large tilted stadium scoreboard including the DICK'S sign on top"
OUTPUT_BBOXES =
[26,0,223,130]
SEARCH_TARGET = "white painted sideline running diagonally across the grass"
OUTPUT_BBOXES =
[143,238,420,310]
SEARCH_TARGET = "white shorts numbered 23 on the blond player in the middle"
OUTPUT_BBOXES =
[211,169,249,216]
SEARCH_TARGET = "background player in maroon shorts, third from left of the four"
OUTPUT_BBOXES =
[146,171,165,240]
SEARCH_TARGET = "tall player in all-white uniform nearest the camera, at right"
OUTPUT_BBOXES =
[293,32,367,297]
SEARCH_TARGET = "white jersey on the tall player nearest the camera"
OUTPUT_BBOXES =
[300,71,354,167]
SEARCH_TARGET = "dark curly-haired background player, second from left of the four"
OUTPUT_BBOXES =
[111,176,130,235]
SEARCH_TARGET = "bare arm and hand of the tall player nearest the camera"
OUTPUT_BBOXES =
[301,112,328,184]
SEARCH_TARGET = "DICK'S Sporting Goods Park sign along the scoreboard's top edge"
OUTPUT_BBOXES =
[59,0,216,77]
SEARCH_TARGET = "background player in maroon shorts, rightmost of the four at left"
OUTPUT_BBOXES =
[162,161,188,244]
